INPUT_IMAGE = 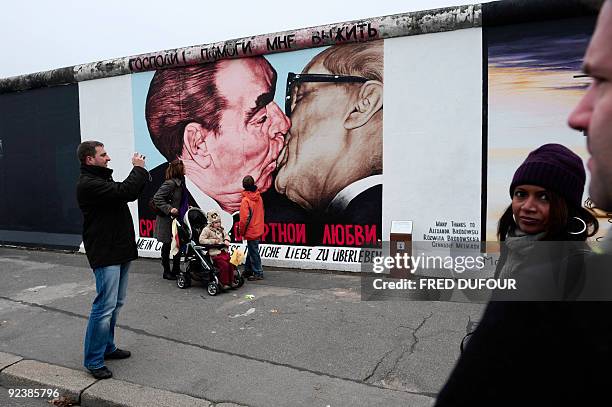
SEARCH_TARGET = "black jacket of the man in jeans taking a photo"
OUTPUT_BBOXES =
[77,165,148,268]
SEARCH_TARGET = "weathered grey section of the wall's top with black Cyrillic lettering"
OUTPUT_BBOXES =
[0,4,482,93]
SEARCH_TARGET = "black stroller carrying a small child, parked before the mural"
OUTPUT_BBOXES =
[176,208,244,295]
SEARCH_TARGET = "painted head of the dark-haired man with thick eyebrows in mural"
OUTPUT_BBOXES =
[146,57,290,212]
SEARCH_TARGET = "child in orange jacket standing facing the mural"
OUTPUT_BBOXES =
[238,175,264,281]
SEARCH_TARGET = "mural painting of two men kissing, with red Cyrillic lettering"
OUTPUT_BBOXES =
[133,41,384,253]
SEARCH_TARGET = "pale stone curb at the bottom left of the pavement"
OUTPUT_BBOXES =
[0,352,244,407]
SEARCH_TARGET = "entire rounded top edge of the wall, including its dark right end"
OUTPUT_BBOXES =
[0,0,604,94]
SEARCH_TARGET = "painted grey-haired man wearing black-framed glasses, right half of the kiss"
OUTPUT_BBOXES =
[275,42,383,223]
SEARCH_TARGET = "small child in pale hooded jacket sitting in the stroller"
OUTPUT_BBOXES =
[199,210,234,290]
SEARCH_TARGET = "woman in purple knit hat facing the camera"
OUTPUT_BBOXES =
[461,144,599,350]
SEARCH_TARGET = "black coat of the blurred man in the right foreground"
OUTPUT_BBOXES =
[436,250,612,407]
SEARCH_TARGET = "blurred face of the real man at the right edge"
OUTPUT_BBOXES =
[569,0,612,210]
